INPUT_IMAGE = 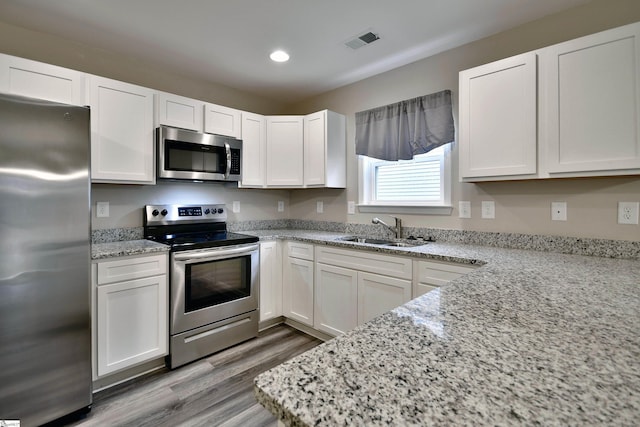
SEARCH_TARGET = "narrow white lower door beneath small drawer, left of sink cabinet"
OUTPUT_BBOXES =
[282,257,313,327]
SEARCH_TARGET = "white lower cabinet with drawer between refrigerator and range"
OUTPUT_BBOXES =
[93,254,169,379]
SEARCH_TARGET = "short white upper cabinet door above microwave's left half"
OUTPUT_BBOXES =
[155,92,205,132]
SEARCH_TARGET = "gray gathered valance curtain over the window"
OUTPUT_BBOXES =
[356,90,455,160]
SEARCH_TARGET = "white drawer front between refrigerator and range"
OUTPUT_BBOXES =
[97,255,167,285]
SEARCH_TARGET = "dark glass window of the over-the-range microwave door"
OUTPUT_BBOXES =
[164,140,227,174]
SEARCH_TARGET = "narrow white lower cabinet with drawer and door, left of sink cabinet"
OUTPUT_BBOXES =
[282,242,314,327]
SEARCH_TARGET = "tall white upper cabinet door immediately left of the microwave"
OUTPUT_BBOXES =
[89,76,155,184]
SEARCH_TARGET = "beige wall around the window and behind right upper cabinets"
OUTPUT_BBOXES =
[290,0,640,240]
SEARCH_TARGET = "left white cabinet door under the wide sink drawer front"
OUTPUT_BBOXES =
[314,264,358,336]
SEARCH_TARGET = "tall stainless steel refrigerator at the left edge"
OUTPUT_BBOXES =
[0,94,92,427]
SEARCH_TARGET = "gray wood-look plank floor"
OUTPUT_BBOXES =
[65,325,321,427]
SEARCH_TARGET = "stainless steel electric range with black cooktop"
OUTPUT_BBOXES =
[144,204,259,369]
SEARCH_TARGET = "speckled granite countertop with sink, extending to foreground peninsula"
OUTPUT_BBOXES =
[248,230,640,426]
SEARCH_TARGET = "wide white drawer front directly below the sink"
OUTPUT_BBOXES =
[316,247,412,279]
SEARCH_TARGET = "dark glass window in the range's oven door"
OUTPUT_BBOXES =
[185,256,251,312]
